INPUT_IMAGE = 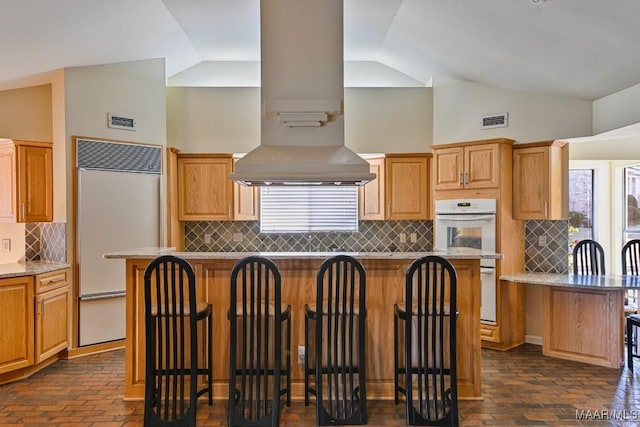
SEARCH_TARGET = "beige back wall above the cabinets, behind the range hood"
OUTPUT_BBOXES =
[167,87,433,153]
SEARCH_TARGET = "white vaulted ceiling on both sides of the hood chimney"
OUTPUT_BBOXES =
[0,0,640,100]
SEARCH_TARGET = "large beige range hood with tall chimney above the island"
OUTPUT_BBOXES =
[229,0,376,186]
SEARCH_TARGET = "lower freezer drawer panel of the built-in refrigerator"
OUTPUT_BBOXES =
[80,297,126,346]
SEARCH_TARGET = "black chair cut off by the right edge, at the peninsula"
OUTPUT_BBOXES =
[622,239,640,372]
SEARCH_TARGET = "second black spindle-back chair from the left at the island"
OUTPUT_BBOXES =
[228,256,291,427]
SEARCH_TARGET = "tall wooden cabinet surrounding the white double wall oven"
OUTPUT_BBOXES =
[431,138,525,350]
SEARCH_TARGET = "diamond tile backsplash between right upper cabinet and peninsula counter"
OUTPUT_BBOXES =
[525,221,569,274]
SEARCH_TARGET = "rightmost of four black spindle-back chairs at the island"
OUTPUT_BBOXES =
[393,256,459,426]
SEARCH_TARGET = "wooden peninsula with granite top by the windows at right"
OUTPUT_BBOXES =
[500,272,640,369]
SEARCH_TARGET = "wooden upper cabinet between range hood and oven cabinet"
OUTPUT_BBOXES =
[359,153,431,220]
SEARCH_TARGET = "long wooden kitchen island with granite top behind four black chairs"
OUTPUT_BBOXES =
[105,248,501,399]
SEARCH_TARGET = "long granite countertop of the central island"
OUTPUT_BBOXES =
[104,248,502,260]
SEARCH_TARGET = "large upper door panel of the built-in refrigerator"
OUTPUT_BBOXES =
[77,170,160,298]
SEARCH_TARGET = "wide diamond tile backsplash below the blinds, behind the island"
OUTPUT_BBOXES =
[185,221,433,252]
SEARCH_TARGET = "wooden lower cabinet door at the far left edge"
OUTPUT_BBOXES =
[0,276,34,374]
